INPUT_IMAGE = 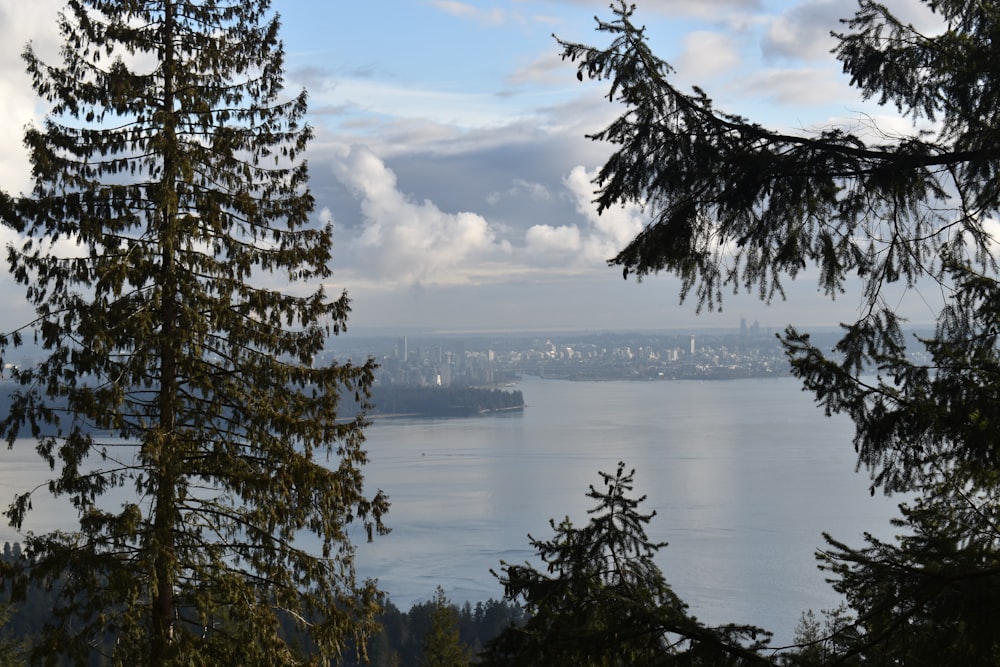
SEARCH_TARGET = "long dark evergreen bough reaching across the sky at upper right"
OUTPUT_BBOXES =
[561,2,1000,320]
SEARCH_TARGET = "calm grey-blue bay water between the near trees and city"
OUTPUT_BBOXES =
[0,378,896,642]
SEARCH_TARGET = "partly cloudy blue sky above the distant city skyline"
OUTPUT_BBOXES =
[0,0,944,334]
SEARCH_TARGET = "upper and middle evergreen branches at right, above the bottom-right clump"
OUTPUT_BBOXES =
[561,0,1000,491]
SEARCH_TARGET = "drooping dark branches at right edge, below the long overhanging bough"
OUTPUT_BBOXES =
[785,267,1000,491]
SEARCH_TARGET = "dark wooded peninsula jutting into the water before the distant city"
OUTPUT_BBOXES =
[358,385,524,417]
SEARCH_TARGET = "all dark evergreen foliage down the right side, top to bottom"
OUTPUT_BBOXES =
[561,0,1000,664]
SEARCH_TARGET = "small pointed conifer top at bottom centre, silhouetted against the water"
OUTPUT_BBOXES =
[482,463,769,665]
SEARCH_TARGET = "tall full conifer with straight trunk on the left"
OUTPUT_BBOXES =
[0,0,388,666]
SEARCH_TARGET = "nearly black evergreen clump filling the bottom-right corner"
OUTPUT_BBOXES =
[819,484,1000,665]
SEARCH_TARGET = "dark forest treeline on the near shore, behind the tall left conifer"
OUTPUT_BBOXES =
[0,543,525,667]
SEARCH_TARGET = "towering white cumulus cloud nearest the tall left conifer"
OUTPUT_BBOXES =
[334,146,510,284]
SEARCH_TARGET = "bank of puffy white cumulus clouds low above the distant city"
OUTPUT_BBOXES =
[320,146,644,287]
